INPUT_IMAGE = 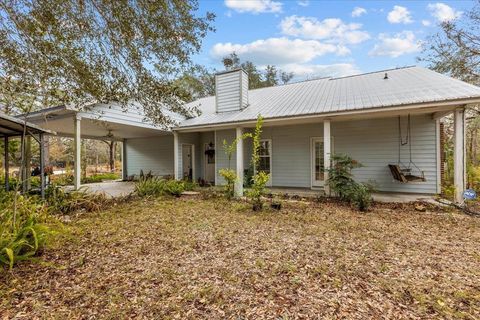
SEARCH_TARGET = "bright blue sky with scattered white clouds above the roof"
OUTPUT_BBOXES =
[194,0,475,79]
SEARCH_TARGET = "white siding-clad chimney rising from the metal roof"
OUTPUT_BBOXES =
[215,69,248,112]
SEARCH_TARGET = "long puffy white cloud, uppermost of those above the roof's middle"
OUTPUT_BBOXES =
[280,15,370,44]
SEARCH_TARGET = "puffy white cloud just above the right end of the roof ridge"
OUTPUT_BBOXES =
[369,31,420,58]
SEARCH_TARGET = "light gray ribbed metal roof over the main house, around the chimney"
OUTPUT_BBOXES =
[179,66,480,128]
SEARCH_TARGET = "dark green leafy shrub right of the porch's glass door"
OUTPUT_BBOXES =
[327,154,373,211]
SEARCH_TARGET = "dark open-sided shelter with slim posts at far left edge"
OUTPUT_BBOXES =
[0,112,55,198]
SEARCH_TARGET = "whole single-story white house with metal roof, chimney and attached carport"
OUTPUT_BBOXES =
[24,67,480,201]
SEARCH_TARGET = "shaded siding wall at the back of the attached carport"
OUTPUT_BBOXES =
[125,135,173,176]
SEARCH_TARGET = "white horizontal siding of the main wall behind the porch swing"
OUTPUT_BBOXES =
[217,115,437,194]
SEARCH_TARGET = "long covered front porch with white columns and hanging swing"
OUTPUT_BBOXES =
[174,104,466,202]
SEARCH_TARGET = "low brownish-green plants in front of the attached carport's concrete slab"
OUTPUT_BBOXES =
[45,185,109,214]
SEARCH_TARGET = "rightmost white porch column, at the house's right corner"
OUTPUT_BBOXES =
[453,108,466,203]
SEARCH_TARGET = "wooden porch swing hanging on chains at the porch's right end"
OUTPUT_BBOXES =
[388,114,426,183]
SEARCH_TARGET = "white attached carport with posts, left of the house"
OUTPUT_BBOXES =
[27,104,171,189]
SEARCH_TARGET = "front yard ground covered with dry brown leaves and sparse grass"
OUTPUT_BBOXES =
[0,198,480,319]
